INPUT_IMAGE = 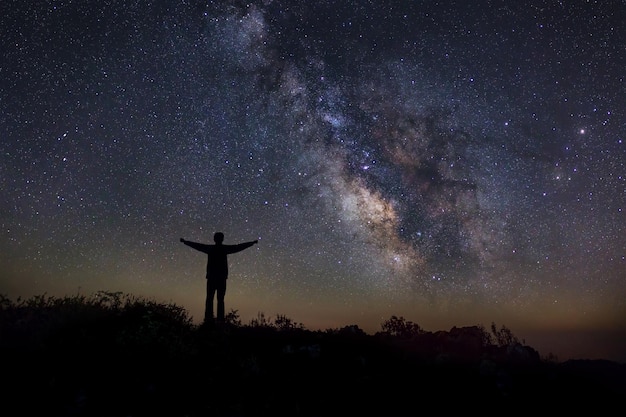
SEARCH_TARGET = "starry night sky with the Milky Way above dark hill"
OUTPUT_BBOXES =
[0,0,626,360]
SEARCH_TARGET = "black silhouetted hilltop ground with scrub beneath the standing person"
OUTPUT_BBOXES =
[0,294,626,417]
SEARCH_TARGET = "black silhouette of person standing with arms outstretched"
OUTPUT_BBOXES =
[180,232,259,323]
